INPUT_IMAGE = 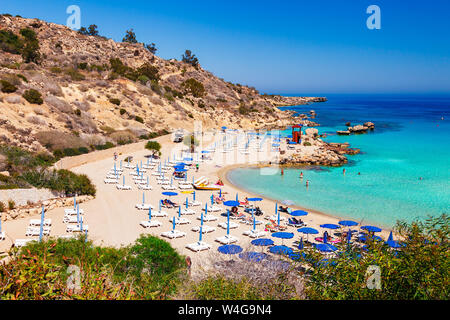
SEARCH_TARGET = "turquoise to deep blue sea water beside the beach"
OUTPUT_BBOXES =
[228,96,450,227]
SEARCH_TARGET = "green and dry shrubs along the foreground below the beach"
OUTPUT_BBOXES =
[0,215,450,300]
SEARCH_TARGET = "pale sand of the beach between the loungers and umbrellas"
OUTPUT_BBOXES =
[0,129,387,267]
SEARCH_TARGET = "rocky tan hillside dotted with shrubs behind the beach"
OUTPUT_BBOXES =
[0,15,324,151]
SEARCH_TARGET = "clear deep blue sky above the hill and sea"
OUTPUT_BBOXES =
[0,0,450,95]
